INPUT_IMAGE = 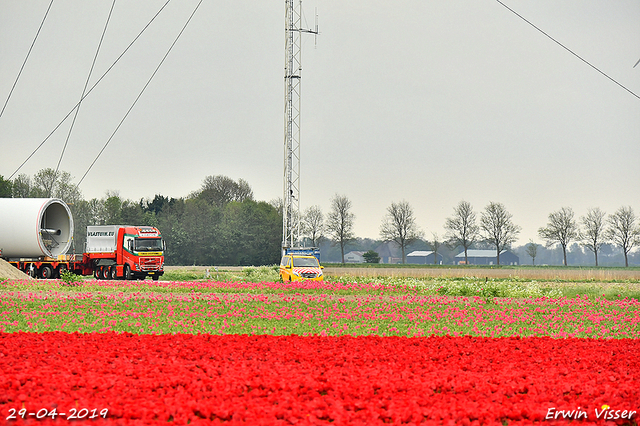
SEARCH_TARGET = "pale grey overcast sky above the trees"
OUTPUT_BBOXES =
[0,0,640,244]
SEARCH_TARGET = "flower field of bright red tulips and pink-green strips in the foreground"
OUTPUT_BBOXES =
[0,281,640,425]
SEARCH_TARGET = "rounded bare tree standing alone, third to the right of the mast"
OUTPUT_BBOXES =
[380,200,422,263]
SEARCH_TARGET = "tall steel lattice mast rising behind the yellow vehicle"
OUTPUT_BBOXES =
[282,0,318,253]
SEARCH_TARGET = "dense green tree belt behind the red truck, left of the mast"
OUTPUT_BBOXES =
[0,169,282,265]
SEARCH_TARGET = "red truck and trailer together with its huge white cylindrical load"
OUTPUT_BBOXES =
[0,198,165,280]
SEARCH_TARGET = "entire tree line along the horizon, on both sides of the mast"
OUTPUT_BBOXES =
[0,169,640,266]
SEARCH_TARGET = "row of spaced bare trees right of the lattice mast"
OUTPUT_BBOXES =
[301,195,640,266]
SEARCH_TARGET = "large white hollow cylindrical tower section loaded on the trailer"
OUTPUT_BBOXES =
[0,198,73,258]
